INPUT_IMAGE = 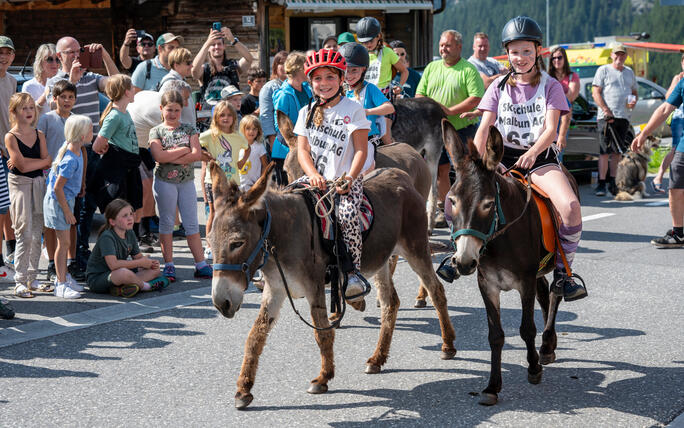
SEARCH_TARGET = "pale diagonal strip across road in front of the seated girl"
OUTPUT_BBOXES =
[0,287,211,348]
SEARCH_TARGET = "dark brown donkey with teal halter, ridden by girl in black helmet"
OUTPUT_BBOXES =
[442,120,564,405]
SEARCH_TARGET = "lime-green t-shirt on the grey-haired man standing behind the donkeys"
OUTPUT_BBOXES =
[416,58,484,129]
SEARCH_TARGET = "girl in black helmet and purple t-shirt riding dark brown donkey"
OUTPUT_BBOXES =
[474,16,587,301]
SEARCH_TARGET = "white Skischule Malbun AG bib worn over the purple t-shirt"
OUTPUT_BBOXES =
[496,71,548,149]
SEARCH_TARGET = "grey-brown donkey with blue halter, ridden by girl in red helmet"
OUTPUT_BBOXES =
[209,162,456,409]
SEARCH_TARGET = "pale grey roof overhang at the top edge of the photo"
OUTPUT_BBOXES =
[272,0,434,13]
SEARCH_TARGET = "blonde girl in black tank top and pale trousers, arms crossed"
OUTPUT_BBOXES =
[5,93,52,297]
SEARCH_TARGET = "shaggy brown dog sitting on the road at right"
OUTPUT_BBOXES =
[615,136,660,201]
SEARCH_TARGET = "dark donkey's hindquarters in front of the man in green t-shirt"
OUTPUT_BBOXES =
[392,97,446,233]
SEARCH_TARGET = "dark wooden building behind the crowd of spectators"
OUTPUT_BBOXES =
[0,0,441,83]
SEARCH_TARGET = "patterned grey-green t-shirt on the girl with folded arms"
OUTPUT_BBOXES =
[150,123,197,184]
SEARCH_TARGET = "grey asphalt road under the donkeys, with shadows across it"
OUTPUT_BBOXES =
[0,176,684,427]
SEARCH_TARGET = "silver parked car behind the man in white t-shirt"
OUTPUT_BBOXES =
[580,77,672,137]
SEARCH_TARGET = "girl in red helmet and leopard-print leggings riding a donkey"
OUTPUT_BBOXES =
[294,49,373,302]
